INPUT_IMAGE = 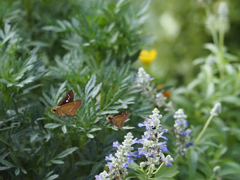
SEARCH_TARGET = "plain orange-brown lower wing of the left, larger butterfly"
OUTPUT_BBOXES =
[61,100,82,117]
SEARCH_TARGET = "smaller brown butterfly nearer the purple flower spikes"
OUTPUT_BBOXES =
[106,111,130,129]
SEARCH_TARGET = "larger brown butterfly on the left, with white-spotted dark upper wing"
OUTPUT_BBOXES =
[51,90,82,117]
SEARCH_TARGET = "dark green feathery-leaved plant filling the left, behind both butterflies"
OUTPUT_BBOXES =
[0,1,154,180]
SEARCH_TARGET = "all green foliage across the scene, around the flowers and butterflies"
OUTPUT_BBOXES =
[0,0,240,180]
